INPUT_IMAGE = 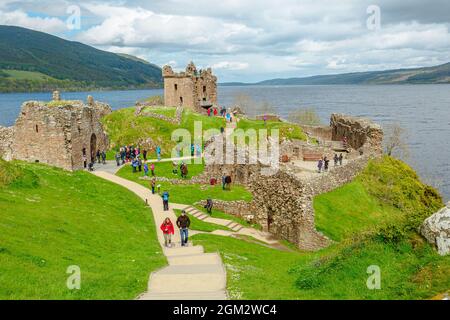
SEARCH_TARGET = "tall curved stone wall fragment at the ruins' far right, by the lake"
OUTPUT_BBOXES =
[330,113,383,153]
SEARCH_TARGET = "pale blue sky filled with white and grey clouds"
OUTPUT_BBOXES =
[0,0,450,82]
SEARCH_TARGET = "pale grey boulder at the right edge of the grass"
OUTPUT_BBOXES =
[420,202,450,256]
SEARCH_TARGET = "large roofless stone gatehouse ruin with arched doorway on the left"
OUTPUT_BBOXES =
[12,101,111,170]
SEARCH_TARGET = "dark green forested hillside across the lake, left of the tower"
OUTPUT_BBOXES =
[0,26,162,92]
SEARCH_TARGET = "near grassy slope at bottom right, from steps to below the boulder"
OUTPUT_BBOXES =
[192,230,450,300]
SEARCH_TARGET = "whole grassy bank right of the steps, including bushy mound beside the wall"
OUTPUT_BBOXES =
[193,157,450,299]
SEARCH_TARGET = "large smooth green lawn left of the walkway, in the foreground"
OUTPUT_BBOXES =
[0,163,166,299]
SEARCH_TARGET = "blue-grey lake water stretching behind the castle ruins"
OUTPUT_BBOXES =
[0,85,450,200]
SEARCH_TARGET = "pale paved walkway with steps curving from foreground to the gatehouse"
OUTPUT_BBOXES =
[93,168,227,300]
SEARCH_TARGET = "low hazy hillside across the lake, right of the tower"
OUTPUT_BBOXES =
[221,63,450,86]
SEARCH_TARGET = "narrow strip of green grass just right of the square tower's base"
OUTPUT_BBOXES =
[237,119,307,141]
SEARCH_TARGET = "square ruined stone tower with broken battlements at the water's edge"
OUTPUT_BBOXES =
[162,62,217,112]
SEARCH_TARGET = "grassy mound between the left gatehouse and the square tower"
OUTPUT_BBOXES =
[102,107,225,156]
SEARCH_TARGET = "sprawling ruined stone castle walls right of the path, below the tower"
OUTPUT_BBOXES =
[198,114,383,250]
